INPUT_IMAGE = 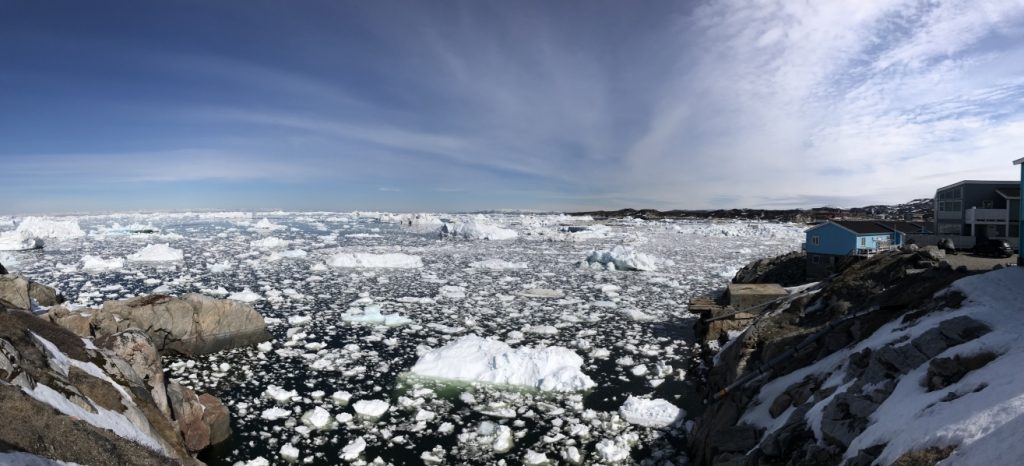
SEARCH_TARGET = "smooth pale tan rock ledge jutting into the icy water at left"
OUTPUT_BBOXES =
[46,294,270,355]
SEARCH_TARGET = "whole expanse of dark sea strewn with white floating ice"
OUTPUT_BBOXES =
[0,212,804,465]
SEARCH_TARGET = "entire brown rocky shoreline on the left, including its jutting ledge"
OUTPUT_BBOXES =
[0,265,269,465]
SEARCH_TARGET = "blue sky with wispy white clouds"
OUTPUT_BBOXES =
[0,0,1024,214]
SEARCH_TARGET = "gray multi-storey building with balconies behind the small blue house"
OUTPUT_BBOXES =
[935,180,1021,243]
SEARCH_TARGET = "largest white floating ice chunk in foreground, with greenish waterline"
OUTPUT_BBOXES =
[411,335,595,391]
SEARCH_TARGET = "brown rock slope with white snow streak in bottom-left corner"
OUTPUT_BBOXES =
[0,309,199,465]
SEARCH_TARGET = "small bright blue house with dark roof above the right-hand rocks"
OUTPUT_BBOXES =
[804,220,930,280]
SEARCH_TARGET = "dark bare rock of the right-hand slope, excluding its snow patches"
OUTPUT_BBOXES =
[688,250,974,465]
